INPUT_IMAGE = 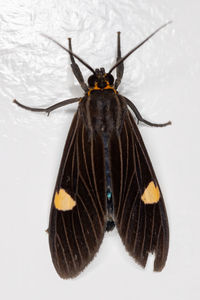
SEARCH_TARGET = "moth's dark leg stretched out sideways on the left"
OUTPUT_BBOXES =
[13,98,81,115]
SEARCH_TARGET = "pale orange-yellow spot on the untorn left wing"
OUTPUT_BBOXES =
[54,189,76,211]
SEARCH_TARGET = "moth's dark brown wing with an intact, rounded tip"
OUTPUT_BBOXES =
[48,111,106,278]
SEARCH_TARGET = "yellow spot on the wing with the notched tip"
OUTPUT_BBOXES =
[141,181,160,204]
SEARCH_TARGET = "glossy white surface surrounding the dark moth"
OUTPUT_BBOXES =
[0,0,200,300]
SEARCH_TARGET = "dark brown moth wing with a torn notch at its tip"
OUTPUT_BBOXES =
[109,112,169,271]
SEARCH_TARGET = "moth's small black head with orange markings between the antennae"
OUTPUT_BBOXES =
[88,68,114,89]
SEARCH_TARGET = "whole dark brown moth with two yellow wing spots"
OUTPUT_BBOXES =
[14,22,171,278]
